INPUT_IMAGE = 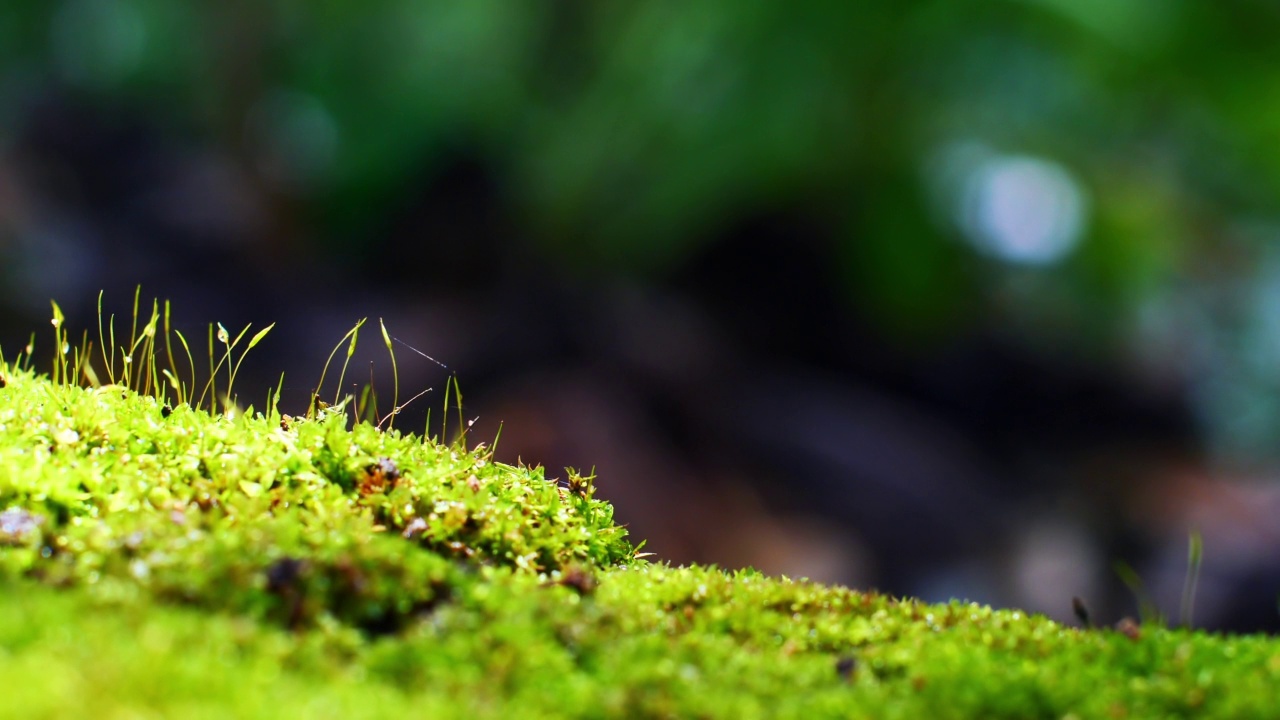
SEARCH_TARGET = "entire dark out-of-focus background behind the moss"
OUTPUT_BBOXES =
[0,0,1280,630]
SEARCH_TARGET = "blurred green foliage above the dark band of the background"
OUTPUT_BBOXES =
[0,0,1280,448]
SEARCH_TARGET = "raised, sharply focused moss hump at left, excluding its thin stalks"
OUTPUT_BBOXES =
[0,370,634,634]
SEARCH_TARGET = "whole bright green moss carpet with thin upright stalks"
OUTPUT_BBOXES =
[0,294,1280,719]
